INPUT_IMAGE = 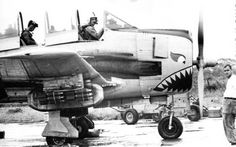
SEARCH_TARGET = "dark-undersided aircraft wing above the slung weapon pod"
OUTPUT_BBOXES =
[0,49,110,86]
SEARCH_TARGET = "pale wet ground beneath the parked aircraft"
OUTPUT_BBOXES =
[0,118,230,147]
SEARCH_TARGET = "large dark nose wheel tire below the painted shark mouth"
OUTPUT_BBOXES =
[158,116,183,139]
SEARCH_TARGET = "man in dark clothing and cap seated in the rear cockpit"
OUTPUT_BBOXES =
[20,20,38,45]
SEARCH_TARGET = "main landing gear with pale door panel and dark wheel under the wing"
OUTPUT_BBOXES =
[42,109,98,146]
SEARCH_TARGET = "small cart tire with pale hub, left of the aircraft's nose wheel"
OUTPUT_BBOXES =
[123,109,139,125]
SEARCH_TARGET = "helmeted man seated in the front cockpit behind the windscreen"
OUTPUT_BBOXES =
[83,17,104,40]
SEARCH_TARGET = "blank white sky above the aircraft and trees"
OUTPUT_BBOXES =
[0,0,236,59]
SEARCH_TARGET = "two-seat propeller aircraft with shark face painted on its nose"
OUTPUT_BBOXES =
[0,11,206,145]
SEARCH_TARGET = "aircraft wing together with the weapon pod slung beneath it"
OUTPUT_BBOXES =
[0,50,116,111]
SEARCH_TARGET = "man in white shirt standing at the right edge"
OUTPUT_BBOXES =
[222,64,236,145]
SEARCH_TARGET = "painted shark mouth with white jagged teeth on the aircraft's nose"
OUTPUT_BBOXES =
[154,67,192,93]
